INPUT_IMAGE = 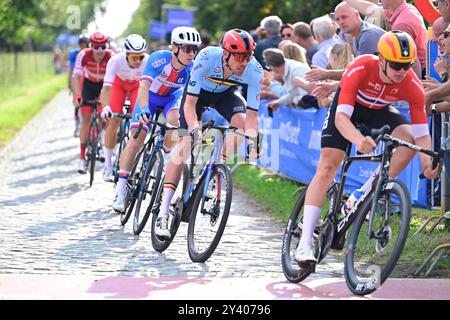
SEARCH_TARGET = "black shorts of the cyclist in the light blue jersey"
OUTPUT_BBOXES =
[180,87,247,134]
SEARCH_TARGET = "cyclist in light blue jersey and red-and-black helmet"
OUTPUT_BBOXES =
[149,29,263,238]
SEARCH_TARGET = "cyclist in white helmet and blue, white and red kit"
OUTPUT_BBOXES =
[112,27,201,212]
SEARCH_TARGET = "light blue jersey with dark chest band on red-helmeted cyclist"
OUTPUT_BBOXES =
[187,47,264,110]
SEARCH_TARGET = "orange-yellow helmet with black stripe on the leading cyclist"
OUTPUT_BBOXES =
[378,31,417,63]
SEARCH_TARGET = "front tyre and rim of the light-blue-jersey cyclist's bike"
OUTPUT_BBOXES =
[188,164,233,262]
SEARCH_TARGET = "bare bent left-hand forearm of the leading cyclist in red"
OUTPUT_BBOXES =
[335,111,377,153]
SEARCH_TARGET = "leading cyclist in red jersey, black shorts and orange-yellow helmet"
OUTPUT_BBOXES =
[294,31,437,263]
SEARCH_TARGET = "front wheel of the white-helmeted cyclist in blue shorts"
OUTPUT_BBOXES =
[133,150,164,235]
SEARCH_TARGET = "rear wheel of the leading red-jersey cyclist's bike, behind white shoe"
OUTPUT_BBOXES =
[281,188,312,283]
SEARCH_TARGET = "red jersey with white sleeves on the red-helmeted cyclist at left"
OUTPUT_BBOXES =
[73,48,114,82]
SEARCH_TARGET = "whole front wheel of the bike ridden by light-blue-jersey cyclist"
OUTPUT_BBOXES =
[188,164,233,262]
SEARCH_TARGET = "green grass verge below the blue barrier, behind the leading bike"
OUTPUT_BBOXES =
[233,165,450,277]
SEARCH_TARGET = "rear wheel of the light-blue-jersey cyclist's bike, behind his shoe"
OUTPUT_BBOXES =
[151,165,189,253]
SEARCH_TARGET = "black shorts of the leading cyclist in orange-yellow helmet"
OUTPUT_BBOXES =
[321,88,410,151]
